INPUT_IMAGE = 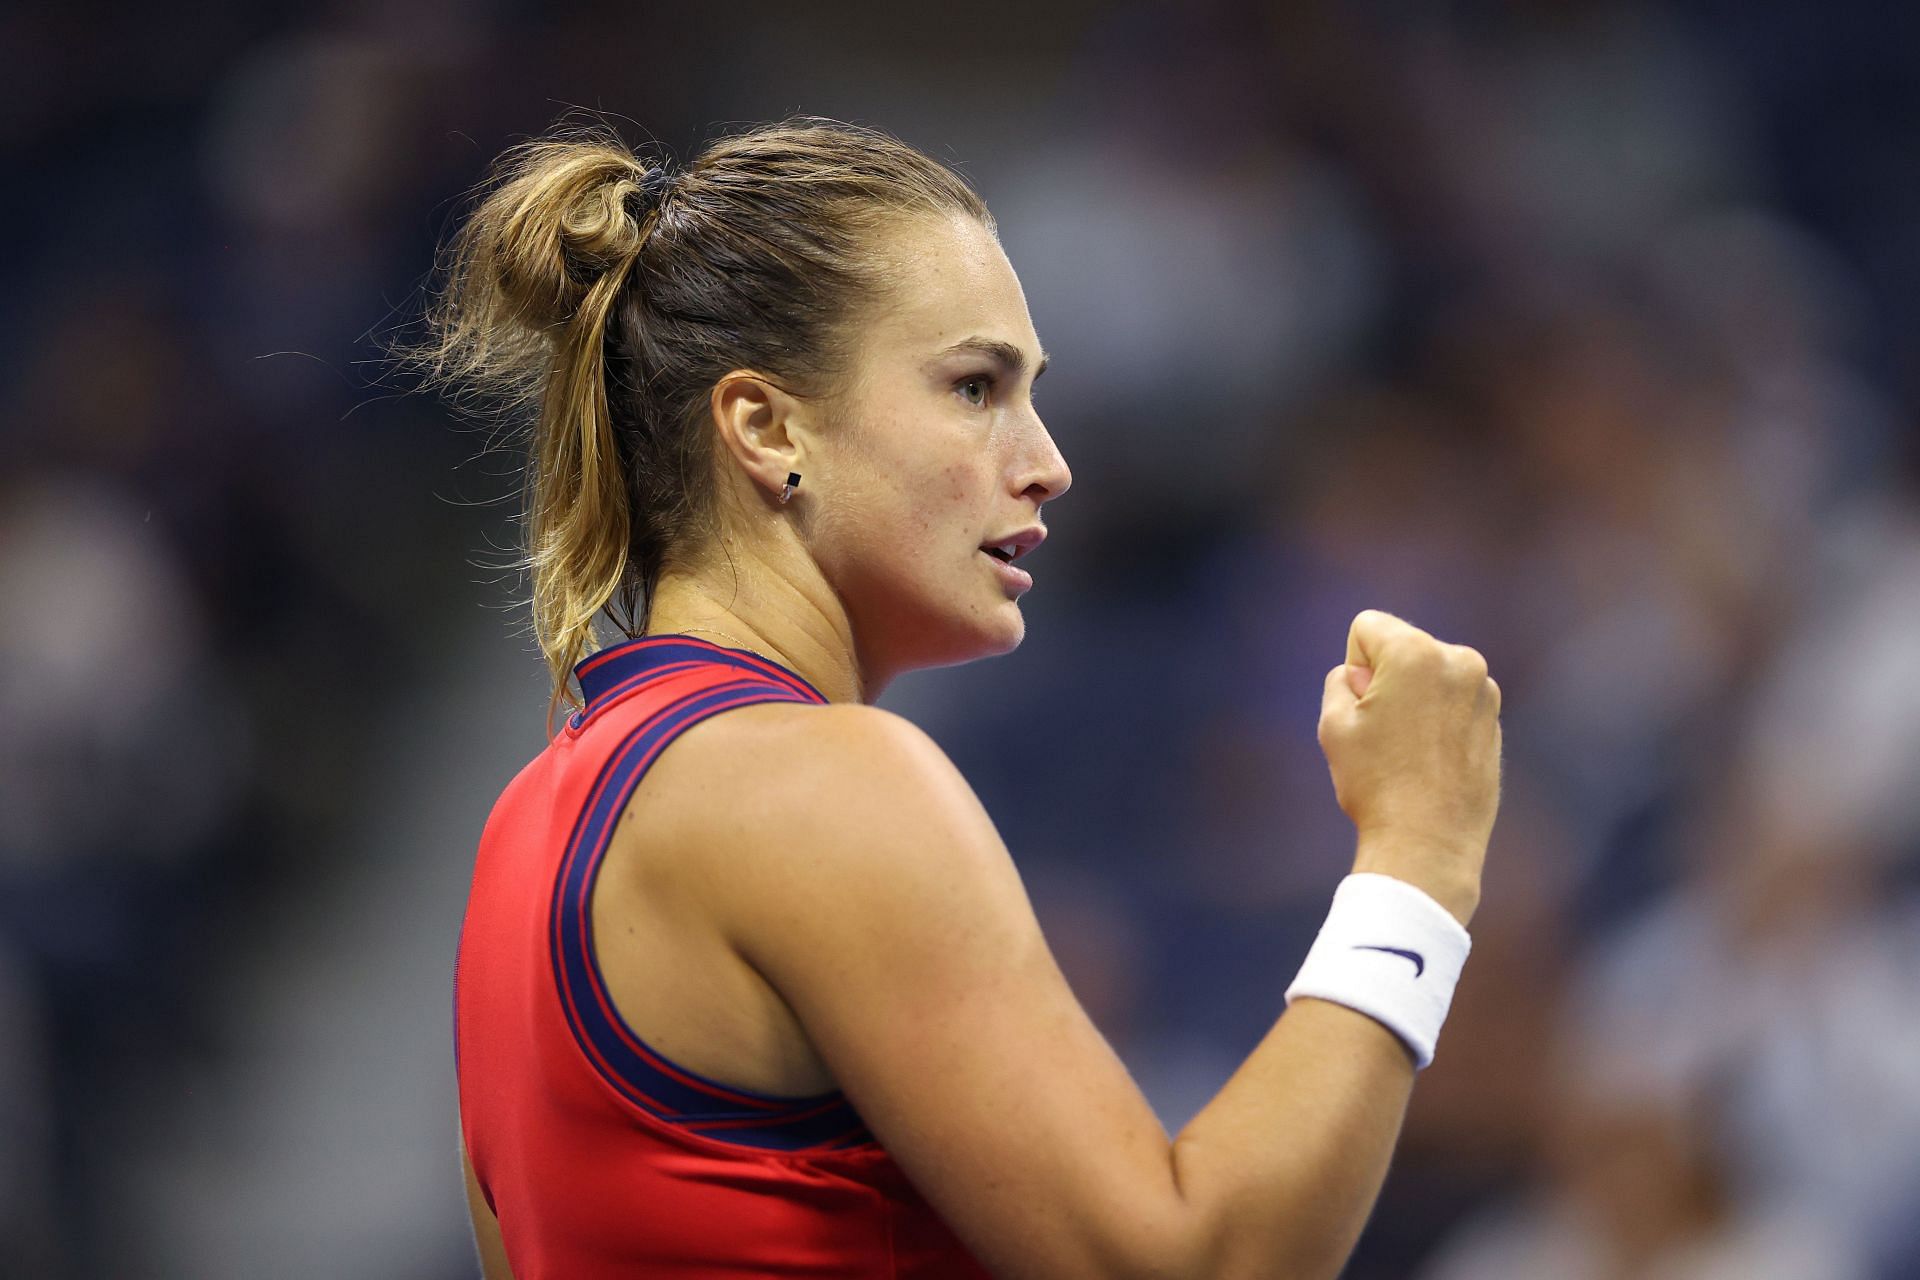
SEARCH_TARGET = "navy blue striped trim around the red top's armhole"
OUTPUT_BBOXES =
[551,679,872,1151]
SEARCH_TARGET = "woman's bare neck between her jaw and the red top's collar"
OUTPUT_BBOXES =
[647,545,879,702]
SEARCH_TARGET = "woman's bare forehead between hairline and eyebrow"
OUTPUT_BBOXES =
[866,215,1039,359]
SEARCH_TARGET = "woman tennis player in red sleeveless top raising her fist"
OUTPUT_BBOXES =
[428,119,1500,1280]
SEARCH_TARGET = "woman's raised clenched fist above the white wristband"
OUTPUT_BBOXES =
[1319,610,1500,925]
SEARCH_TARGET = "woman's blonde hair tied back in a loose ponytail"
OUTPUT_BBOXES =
[411,117,993,702]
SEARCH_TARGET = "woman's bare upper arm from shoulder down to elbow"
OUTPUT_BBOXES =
[691,706,1192,1276]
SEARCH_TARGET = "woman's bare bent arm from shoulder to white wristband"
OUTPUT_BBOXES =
[703,624,1498,1276]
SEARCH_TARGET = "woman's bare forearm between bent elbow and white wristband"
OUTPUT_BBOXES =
[1173,1000,1413,1276]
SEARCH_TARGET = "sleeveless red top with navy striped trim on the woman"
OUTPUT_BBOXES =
[453,635,985,1280]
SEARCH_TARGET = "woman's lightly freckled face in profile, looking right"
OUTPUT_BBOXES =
[806,217,1071,687]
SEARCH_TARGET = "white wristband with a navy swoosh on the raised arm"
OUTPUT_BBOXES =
[1286,871,1473,1067]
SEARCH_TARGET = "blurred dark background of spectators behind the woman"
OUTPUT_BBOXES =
[0,0,1920,1280]
